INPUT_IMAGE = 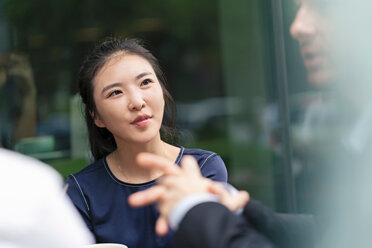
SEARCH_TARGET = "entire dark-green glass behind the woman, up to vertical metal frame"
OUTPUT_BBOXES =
[0,0,293,211]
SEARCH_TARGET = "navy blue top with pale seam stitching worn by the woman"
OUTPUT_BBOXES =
[66,147,227,248]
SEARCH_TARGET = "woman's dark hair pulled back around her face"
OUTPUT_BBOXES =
[78,38,176,160]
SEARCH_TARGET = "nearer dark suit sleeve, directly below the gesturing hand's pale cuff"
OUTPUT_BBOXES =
[173,202,274,248]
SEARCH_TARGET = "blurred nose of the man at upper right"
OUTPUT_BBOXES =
[290,6,317,42]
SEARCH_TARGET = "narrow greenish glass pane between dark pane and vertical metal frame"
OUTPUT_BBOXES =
[219,0,288,211]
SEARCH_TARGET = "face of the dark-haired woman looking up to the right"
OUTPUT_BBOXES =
[93,53,164,143]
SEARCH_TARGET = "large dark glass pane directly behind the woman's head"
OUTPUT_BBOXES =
[0,0,228,176]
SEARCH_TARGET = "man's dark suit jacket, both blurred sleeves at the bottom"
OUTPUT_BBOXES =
[173,199,314,248]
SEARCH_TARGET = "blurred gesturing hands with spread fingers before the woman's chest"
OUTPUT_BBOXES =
[128,153,249,236]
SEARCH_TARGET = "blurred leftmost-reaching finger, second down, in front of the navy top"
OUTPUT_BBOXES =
[128,185,165,207]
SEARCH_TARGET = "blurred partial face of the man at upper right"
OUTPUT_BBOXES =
[290,0,333,87]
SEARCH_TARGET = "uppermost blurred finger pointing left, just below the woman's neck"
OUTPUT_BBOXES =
[137,153,181,175]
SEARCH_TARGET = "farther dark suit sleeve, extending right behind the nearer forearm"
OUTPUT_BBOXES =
[243,199,315,248]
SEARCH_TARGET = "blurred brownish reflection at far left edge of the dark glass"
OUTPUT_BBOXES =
[0,52,36,149]
